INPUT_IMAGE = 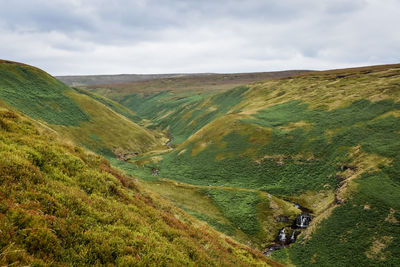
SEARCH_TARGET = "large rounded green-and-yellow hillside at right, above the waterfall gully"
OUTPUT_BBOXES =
[170,64,400,195]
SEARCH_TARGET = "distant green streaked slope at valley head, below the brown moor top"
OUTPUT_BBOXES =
[114,86,248,144]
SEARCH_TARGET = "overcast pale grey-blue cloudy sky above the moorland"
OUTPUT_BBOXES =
[0,0,400,75]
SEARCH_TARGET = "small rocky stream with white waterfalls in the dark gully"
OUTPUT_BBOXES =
[263,202,312,256]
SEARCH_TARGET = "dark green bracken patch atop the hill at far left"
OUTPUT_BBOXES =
[0,61,90,126]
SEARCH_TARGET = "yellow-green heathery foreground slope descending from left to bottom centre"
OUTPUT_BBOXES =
[0,103,279,266]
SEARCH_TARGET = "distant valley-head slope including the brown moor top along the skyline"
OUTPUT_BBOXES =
[85,70,305,144]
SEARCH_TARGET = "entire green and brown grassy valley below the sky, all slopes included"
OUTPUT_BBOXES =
[0,61,400,266]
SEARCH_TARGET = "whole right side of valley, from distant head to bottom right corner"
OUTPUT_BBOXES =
[91,65,400,266]
